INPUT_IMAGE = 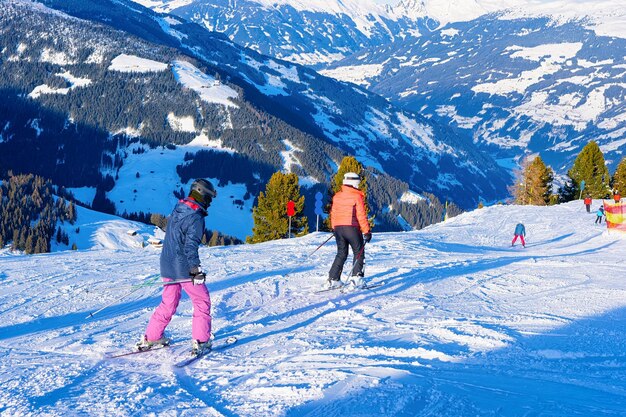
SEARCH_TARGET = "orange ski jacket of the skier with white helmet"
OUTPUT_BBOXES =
[330,185,370,233]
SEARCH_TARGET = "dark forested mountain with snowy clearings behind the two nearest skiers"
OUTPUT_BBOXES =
[0,0,508,238]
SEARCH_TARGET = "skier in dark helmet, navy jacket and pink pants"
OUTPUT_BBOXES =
[137,179,217,354]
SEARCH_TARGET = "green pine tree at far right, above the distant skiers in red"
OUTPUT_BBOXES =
[567,141,610,199]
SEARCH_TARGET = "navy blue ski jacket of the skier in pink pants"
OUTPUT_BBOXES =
[161,198,207,279]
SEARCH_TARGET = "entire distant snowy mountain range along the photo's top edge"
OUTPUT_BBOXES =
[135,0,626,68]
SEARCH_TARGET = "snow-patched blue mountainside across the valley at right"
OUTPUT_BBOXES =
[323,14,626,172]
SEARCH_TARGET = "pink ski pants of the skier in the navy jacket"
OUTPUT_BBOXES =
[146,278,211,342]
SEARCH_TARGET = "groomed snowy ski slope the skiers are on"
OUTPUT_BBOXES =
[0,202,626,417]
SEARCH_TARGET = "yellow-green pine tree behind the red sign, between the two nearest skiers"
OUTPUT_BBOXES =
[246,172,309,243]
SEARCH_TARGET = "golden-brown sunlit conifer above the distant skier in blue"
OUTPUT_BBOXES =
[512,156,554,206]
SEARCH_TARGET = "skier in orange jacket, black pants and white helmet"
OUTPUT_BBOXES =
[325,172,372,288]
